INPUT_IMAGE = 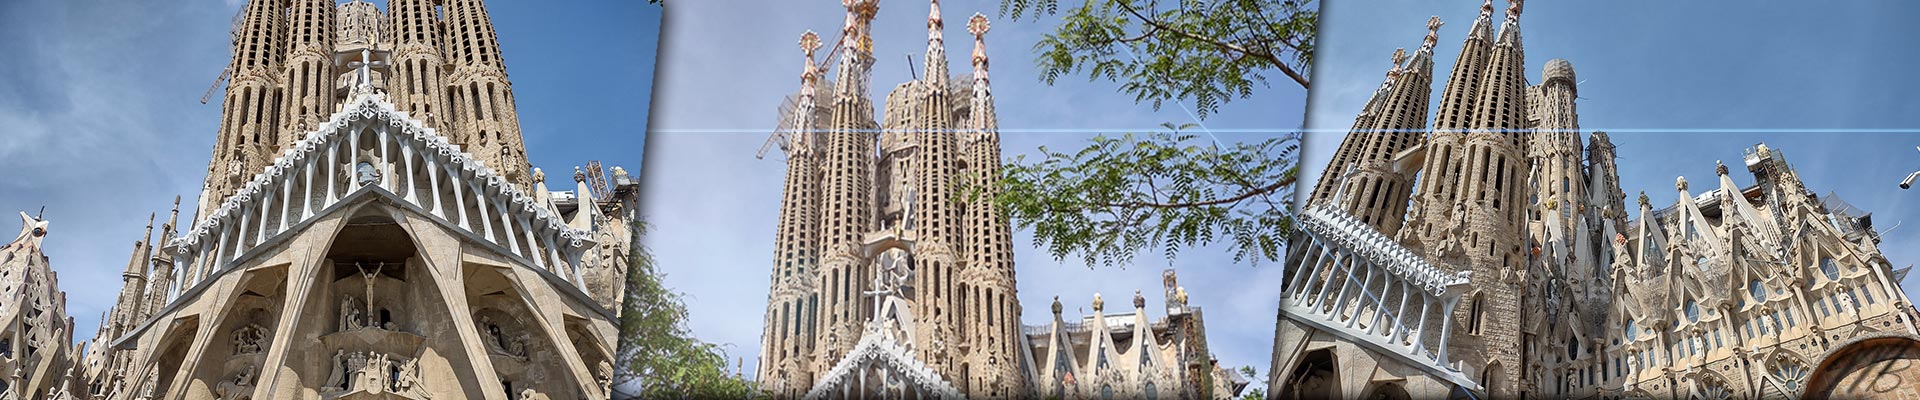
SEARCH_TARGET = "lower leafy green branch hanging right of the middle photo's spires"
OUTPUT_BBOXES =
[995,125,1300,267]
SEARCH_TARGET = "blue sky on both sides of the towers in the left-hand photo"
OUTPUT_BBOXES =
[0,0,660,340]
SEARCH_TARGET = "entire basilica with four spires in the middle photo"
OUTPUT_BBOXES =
[756,0,1246,398]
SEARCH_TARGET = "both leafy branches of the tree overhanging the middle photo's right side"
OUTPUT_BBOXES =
[996,0,1319,265]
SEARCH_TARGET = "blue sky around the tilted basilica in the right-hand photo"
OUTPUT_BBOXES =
[1302,0,1920,309]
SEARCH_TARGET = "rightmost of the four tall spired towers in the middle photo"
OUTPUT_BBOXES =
[956,13,1027,398]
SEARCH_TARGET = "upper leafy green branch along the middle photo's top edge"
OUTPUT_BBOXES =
[1000,0,1319,117]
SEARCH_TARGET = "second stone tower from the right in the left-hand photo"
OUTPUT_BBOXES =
[386,0,453,134]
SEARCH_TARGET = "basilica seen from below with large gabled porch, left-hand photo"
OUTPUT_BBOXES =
[0,0,637,400]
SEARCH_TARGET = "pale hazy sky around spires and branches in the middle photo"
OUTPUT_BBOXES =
[641,0,1306,390]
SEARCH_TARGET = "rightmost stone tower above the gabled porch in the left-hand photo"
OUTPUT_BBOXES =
[445,0,532,188]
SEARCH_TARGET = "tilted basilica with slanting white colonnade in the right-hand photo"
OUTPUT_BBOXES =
[1269,0,1920,398]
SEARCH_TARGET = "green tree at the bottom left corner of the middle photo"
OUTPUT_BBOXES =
[614,223,766,398]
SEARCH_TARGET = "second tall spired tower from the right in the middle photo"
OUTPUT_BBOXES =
[912,0,964,375]
